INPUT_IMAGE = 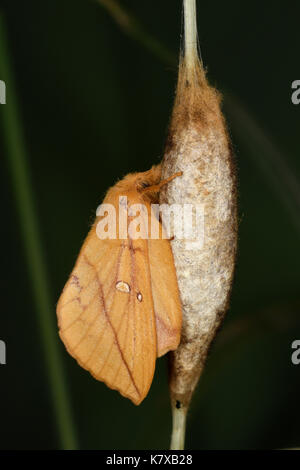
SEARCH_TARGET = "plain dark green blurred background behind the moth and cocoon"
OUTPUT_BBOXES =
[0,0,300,449]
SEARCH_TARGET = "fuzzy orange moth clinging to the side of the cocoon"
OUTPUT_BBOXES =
[57,165,182,405]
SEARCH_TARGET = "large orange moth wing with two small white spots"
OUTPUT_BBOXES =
[57,224,157,405]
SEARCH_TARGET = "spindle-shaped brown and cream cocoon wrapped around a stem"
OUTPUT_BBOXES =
[160,53,237,409]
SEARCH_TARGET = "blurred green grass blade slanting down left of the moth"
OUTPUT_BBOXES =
[0,12,77,449]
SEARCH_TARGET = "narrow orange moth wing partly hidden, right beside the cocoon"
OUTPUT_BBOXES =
[148,235,182,357]
